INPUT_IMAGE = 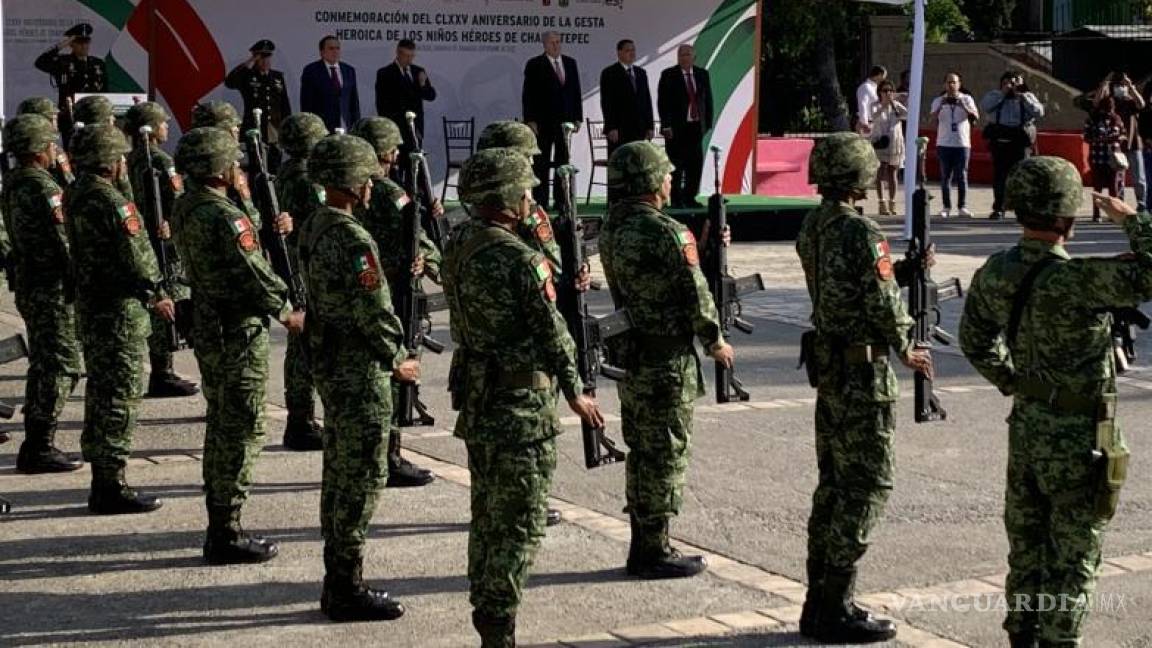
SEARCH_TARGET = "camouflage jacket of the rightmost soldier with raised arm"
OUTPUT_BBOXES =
[960,214,1152,394]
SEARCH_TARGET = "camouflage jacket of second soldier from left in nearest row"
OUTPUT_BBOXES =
[65,173,165,303]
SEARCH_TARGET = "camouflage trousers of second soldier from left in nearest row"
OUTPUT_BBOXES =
[76,299,149,480]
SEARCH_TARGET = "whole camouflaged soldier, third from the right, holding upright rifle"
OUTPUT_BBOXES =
[600,142,733,579]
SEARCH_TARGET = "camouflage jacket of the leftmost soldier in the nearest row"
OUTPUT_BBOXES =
[2,167,71,292]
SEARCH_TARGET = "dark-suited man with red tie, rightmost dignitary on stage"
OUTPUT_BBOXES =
[657,45,714,208]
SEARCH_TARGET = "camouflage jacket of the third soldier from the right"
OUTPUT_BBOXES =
[600,199,722,351]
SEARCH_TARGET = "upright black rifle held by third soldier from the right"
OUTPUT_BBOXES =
[702,146,764,402]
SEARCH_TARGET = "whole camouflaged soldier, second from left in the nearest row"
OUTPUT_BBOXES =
[63,123,175,514]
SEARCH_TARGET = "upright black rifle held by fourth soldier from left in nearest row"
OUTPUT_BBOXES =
[393,151,447,428]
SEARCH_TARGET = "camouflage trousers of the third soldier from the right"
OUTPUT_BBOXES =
[619,352,700,525]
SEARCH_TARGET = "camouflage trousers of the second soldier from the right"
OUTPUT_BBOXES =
[808,393,896,570]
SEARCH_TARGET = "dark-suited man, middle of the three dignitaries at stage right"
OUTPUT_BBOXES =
[600,39,655,156]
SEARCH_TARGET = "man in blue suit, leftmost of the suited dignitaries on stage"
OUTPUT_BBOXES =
[300,35,359,130]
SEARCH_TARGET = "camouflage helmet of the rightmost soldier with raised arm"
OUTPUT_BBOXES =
[1005,156,1084,218]
